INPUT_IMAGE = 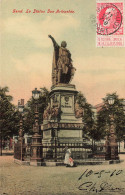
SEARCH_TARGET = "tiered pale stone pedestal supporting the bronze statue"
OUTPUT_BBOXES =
[41,84,83,144]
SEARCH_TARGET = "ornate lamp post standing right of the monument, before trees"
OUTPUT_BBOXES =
[107,96,119,160]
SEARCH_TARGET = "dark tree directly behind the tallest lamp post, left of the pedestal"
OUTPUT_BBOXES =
[23,87,49,134]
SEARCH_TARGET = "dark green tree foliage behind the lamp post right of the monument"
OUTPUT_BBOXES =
[97,93,125,141]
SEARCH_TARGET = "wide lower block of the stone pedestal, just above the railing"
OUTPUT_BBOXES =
[42,122,83,144]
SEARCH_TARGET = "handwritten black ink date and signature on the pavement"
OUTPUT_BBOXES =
[78,169,125,193]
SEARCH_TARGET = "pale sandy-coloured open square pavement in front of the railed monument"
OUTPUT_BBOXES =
[0,155,125,195]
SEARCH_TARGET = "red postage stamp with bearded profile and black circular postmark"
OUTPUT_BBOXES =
[96,0,125,47]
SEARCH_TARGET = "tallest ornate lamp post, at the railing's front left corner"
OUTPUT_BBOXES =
[30,88,42,166]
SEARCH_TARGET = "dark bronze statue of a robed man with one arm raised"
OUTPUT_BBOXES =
[48,35,75,85]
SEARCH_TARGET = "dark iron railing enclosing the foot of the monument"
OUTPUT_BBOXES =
[14,142,105,162]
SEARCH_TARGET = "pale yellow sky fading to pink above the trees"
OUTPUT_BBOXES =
[0,0,125,105]
